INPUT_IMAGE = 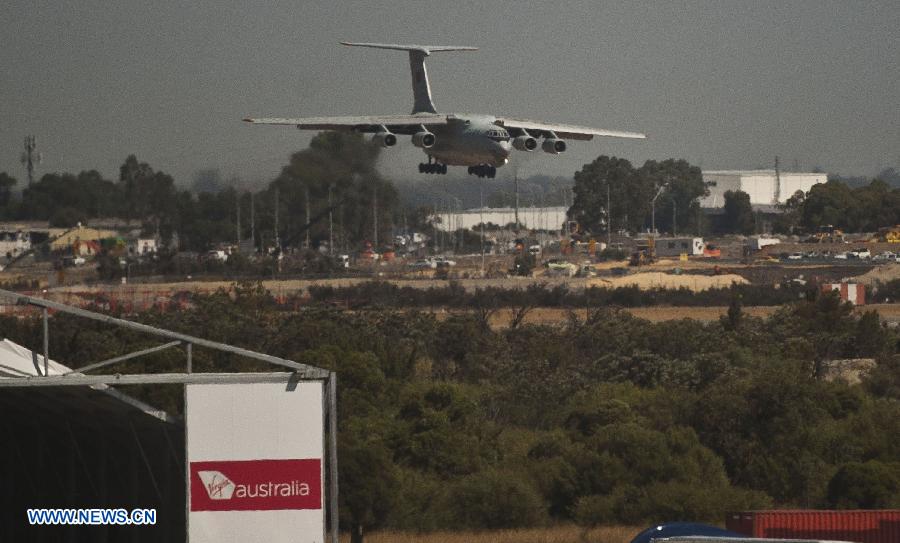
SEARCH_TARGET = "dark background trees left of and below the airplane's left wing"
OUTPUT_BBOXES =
[0,136,401,255]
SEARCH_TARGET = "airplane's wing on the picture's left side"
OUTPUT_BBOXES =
[244,114,450,134]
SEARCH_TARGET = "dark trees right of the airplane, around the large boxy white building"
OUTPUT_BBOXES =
[569,155,900,236]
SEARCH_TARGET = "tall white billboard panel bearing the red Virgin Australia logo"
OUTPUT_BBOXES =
[185,381,325,543]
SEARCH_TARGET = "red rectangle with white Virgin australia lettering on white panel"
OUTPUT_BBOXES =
[191,458,322,511]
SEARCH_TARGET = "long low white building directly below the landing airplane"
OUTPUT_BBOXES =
[435,206,568,232]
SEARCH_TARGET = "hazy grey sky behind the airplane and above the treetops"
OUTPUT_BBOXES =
[0,0,900,189]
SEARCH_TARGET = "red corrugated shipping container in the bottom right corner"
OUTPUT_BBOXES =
[725,509,900,543]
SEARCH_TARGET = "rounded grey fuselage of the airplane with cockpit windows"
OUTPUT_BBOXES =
[422,113,512,168]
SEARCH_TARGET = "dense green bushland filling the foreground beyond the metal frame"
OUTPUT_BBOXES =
[0,285,900,532]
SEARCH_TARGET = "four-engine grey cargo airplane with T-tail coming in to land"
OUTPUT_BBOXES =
[244,42,646,178]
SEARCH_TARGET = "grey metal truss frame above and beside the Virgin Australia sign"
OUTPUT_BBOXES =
[0,289,339,543]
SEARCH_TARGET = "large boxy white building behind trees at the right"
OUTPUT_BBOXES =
[700,170,828,208]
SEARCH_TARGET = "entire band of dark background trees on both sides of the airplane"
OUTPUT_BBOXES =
[0,147,900,255]
